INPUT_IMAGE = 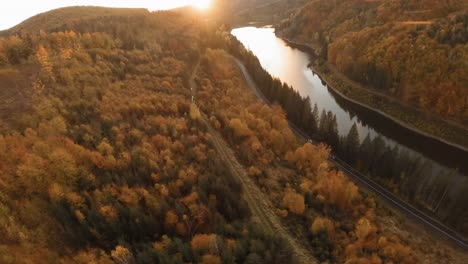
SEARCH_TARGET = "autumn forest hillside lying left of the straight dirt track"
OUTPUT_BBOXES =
[0,8,290,263]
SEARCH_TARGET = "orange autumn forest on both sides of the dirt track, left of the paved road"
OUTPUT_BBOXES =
[0,7,466,264]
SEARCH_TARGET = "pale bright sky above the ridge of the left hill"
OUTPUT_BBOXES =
[0,0,206,30]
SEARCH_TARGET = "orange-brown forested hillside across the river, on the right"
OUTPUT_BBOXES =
[278,0,468,125]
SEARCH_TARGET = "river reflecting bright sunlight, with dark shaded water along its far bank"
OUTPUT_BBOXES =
[231,27,468,217]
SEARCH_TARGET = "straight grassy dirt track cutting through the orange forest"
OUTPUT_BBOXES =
[190,54,318,264]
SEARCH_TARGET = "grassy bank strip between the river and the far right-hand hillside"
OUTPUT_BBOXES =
[275,33,468,152]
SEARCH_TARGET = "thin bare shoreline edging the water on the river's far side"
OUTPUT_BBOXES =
[275,35,468,153]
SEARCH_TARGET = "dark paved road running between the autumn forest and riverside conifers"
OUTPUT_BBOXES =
[234,58,468,250]
